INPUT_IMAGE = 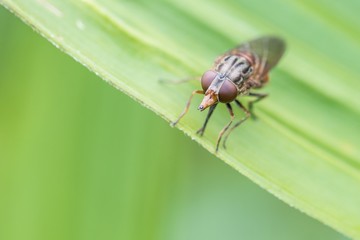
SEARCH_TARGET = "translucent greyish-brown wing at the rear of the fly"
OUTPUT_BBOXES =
[229,37,285,78]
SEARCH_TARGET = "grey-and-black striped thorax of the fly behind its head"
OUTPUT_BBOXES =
[215,55,253,86]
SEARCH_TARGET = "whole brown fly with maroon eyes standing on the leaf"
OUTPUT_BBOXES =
[172,37,285,151]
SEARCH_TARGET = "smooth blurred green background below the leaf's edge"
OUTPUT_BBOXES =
[0,7,346,240]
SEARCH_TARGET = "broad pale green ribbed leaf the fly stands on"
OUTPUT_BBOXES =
[1,0,360,238]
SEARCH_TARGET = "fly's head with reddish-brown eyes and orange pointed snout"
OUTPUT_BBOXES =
[198,70,238,111]
